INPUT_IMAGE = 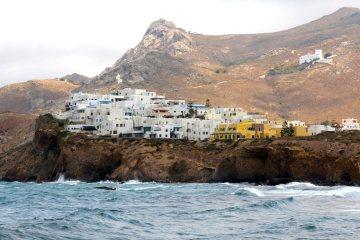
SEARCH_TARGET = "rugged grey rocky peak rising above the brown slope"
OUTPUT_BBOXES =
[93,19,193,85]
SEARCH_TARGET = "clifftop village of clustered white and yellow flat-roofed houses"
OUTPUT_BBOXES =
[56,88,360,141]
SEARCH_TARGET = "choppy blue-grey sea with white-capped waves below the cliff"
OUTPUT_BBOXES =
[0,181,360,239]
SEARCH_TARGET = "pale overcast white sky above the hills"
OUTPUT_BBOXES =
[0,0,360,87]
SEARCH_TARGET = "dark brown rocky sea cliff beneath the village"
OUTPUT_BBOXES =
[0,115,360,185]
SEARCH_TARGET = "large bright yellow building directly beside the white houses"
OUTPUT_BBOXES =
[211,121,255,141]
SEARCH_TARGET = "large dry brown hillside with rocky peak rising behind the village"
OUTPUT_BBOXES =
[88,8,360,122]
